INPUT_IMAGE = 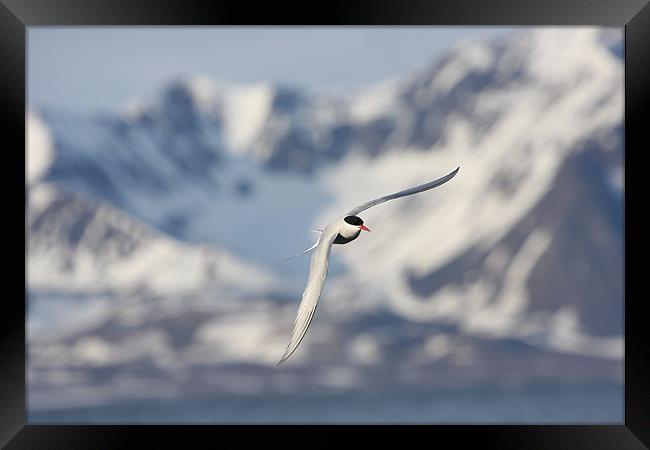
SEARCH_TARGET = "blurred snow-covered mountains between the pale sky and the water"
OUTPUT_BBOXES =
[27,28,624,406]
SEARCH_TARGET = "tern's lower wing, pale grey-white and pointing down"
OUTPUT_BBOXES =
[278,226,338,365]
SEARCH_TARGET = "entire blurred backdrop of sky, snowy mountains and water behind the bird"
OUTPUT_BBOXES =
[26,27,624,423]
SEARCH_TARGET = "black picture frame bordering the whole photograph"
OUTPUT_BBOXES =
[0,0,650,449]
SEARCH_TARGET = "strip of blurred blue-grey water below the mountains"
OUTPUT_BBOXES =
[29,384,624,424]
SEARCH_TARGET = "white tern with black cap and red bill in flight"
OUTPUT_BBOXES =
[278,167,460,365]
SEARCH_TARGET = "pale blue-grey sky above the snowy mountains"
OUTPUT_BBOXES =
[28,27,509,110]
